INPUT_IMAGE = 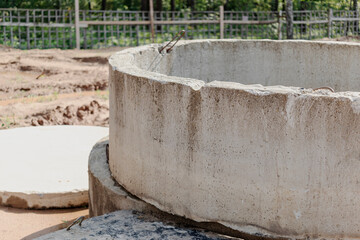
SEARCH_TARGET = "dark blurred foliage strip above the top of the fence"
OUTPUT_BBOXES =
[0,0,357,11]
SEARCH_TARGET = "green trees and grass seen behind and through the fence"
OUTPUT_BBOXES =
[0,0,359,49]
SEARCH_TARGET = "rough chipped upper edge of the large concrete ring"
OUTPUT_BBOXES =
[108,39,360,109]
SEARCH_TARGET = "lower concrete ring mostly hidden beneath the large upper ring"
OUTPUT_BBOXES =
[89,138,258,239]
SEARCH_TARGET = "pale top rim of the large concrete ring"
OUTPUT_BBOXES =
[109,39,360,97]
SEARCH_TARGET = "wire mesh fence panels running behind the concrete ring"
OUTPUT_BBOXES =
[0,9,360,49]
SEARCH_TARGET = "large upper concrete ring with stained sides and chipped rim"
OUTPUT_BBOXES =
[109,40,360,239]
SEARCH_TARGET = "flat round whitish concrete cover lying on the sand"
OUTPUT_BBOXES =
[0,126,109,208]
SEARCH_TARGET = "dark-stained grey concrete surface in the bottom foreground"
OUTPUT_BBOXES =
[37,210,230,240]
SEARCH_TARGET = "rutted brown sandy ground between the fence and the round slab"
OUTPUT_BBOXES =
[0,47,124,129]
